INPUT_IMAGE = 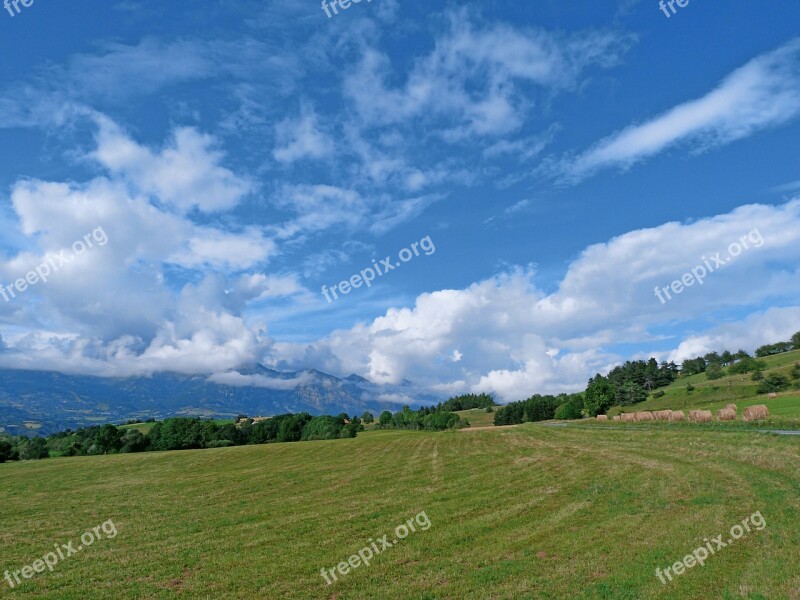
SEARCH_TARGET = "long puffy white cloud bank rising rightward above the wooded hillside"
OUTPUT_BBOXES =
[286,200,800,400]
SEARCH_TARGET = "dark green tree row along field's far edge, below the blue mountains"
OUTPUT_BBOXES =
[0,413,364,463]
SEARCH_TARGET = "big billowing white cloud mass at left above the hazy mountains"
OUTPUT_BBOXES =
[0,111,282,375]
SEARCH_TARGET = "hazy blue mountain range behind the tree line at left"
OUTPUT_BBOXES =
[0,365,441,433]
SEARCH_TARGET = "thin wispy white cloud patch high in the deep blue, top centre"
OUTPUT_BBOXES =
[345,10,630,141]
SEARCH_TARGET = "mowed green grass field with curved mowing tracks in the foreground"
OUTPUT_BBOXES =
[0,424,800,600]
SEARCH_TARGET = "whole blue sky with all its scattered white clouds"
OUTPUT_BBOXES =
[0,0,800,400]
